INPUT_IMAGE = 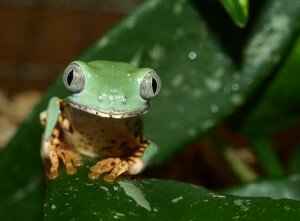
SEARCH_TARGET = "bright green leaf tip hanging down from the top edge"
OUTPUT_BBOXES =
[219,0,249,28]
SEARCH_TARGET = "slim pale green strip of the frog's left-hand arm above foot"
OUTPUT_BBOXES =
[43,97,61,141]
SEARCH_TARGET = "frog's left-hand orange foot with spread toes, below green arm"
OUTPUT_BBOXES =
[42,134,82,179]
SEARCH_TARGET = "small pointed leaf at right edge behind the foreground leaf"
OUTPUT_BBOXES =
[222,174,300,200]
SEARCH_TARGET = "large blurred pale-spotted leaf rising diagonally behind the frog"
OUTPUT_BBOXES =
[0,0,300,220]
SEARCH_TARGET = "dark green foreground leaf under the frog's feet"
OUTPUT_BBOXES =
[44,167,300,221]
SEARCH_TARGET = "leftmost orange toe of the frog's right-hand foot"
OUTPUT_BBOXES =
[89,158,121,180]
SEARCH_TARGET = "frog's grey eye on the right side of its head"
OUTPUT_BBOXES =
[140,71,161,100]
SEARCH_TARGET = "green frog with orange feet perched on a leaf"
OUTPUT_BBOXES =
[40,60,161,182]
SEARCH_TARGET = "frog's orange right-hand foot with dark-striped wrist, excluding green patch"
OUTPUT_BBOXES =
[89,144,148,182]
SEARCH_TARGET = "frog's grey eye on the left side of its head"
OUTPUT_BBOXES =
[63,63,84,93]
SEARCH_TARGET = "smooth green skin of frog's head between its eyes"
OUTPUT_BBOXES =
[67,61,152,118]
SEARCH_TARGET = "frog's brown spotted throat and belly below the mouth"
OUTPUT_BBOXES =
[63,106,143,158]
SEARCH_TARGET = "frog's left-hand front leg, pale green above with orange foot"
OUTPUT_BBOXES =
[40,98,82,179]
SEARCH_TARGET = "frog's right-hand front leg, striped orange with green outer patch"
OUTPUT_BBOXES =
[89,141,157,182]
